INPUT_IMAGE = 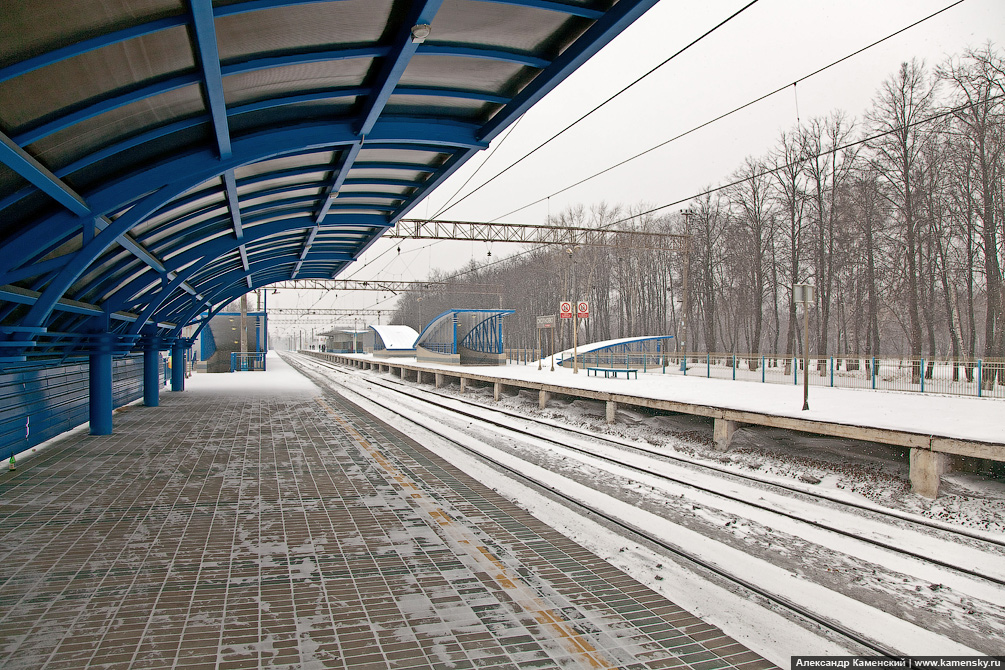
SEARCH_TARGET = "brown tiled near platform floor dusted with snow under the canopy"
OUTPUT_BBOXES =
[0,361,770,670]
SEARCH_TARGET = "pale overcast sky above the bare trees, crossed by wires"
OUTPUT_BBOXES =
[270,0,1005,337]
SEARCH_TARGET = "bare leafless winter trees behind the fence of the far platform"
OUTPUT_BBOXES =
[393,44,1005,383]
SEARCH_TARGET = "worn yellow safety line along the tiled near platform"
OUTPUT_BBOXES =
[317,398,617,670]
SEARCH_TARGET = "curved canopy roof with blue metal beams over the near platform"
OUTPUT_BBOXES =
[0,0,656,363]
